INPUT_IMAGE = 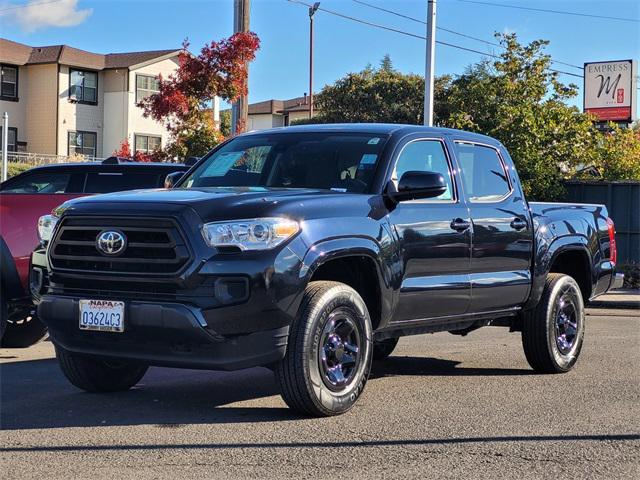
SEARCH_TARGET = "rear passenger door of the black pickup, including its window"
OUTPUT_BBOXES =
[454,141,533,313]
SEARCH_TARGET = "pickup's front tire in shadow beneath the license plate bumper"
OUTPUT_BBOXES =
[56,345,149,393]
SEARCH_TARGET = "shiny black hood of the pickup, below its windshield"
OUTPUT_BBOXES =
[64,187,380,222]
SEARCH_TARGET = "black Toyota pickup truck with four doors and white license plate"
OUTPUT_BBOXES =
[31,124,621,416]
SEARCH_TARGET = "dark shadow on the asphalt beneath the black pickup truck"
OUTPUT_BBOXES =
[0,357,531,430]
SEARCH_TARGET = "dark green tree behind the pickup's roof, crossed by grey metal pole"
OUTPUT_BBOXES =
[314,55,451,124]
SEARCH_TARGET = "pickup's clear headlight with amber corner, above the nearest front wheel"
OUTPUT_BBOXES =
[202,218,300,250]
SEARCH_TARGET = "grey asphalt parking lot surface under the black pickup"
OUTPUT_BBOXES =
[0,310,640,479]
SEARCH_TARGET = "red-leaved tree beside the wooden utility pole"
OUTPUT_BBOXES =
[138,32,260,158]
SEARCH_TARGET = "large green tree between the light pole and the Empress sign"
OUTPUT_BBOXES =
[444,34,599,200]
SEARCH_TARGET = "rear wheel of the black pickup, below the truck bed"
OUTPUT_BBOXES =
[522,273,585,373]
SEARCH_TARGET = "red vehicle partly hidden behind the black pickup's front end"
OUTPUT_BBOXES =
[0,157,189,348]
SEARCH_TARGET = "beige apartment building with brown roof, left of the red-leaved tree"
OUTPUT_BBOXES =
[0,39,180,158]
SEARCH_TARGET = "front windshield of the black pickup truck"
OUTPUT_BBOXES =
[177,132,387,193]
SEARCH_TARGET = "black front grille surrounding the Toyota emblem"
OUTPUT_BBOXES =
[49,217,190,277]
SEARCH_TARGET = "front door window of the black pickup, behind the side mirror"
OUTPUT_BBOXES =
[391,140,453,201]
